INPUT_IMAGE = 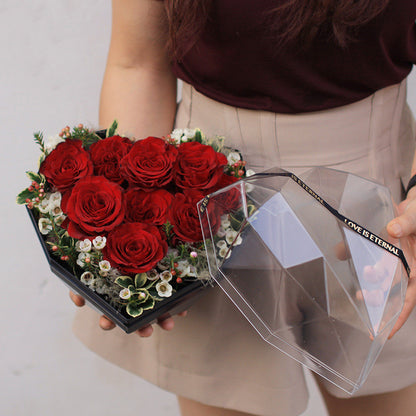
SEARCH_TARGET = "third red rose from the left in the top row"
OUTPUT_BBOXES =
[121,137,178,188]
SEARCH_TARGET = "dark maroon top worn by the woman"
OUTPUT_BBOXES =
[173,0,416,113]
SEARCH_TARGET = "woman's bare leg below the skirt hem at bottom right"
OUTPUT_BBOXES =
[317,379,416,416]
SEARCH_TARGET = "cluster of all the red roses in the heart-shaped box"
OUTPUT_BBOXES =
[39,136,237,273]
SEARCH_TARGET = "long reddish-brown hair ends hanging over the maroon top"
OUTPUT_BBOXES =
[165,0,389,59]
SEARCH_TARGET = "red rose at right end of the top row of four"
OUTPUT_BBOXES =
[174,142,227,189]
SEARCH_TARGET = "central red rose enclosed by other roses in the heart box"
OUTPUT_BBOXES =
[124,189,173,225]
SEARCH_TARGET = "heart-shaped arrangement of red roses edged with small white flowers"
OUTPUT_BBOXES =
[17,122,246,317]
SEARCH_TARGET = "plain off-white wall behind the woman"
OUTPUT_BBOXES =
[0,0,416,416]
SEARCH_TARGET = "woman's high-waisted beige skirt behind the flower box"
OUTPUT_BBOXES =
[74,82,416,416]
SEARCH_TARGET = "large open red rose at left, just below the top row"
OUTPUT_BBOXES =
[61,176,124,239]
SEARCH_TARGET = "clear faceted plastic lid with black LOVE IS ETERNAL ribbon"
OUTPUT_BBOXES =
[198,167,409,394]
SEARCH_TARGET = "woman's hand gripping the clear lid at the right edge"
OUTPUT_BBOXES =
[387,188,416,339]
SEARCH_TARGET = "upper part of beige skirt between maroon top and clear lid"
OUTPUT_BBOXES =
[176,80,415,202]
